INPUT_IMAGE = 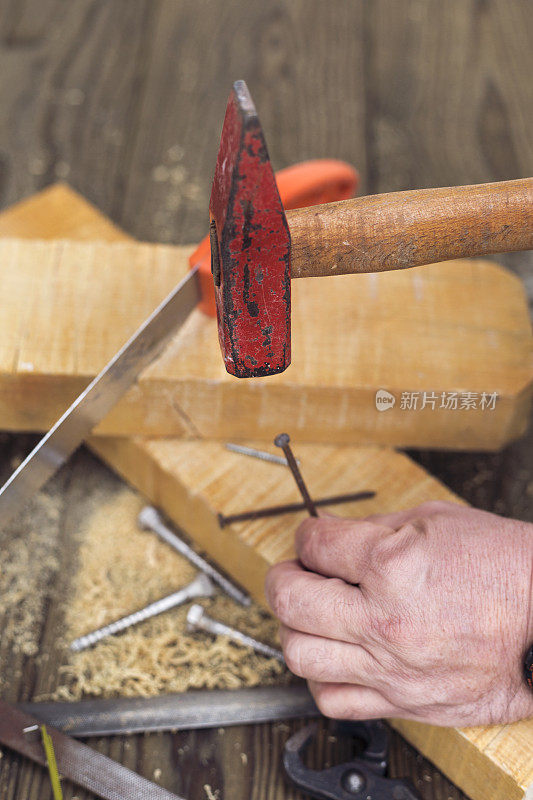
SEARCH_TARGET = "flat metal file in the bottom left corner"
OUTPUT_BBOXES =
[0,700,182,800]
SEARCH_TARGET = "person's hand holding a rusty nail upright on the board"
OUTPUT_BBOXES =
[266,502,533,726]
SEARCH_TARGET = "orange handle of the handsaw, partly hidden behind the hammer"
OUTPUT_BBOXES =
[189,158,359,317]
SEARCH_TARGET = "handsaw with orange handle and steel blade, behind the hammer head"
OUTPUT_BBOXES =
[0,159,359,530]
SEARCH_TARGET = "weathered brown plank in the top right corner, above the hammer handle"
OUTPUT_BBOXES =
[366,0,533,193]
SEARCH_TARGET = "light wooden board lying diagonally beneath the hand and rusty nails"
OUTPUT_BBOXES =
[4,183,533,800]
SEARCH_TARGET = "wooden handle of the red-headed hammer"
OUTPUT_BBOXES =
[287,178,533,278]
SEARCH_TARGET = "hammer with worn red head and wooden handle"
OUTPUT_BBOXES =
[209,81,533,378]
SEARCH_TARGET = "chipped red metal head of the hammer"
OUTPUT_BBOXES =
[209,81,291,378]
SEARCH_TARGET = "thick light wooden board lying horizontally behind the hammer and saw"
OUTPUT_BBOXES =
[0,185,533,450]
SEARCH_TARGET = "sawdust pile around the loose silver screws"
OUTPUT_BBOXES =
[54,489,289,700]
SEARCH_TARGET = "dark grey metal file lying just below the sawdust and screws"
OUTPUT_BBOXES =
[19,684,320,736]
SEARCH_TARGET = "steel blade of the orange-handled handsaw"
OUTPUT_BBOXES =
[0,269,201,530]
